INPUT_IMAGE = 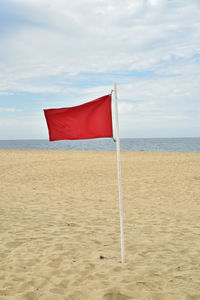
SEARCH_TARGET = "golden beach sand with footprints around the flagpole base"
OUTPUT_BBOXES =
[0,150,200,300]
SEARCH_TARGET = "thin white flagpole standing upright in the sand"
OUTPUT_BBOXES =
[114,82,124,263]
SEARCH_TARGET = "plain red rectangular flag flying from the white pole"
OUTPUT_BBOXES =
[44,95,113,141]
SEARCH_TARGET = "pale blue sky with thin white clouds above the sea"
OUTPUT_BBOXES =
[0,0,200,139]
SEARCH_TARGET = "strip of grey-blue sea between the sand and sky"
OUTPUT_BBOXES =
[0,137,200,152]
